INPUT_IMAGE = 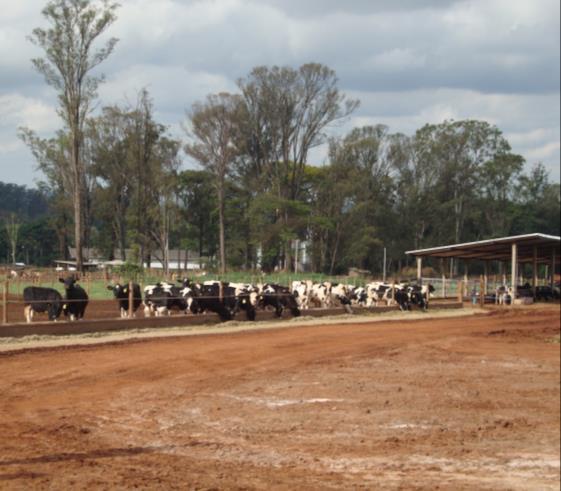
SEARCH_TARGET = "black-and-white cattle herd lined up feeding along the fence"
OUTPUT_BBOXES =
[23,276,434,322]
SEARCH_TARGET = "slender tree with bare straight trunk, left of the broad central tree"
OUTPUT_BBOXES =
[185,93,241,273]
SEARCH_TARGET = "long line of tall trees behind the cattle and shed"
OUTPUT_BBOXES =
[8,0,560,273]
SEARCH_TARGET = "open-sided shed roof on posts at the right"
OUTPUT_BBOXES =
[406,233,561,298]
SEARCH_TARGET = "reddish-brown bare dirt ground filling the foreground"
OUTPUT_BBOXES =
[0,304,560,490]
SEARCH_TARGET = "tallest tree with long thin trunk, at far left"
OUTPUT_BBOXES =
[30,0,117,270]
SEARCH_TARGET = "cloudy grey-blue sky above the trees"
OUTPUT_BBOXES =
[0,0,560,186]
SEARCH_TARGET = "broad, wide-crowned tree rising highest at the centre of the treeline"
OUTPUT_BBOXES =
[238,63,358,268]
